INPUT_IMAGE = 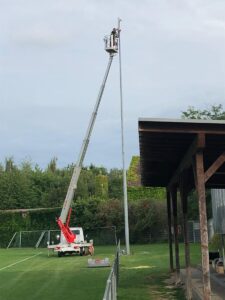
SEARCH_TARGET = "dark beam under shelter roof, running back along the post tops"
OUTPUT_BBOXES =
[168,133,205,189]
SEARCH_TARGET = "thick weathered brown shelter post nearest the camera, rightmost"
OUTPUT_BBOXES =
[196,151,211,300]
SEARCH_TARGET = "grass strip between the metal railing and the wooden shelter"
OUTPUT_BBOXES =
[119,244,201,300]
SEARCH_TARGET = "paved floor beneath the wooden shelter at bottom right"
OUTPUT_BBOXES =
[181,268,225,300]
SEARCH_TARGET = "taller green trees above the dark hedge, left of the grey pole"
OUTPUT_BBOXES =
[0,158,122,209]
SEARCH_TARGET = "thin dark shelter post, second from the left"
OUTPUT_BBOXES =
[171,187,181,284]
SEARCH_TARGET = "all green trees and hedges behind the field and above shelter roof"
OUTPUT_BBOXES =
[0,105,225,246]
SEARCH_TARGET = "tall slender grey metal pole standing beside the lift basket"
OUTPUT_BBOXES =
[118,18,130,255]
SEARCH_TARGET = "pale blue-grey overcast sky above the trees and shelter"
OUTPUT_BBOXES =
[0,0,225,168]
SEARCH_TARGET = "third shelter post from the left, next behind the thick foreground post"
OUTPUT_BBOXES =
[180,174,192,300]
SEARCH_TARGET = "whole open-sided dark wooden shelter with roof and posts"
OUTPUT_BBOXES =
[139,119,225,300]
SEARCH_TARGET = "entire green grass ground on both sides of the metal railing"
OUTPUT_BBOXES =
[0,244,200,300]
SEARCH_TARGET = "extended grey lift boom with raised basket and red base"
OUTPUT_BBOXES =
[57,28,119,243]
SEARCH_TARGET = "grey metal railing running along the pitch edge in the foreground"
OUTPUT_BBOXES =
[103,241,120,300]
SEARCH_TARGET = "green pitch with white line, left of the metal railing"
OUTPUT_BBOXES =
[0,247,114,300]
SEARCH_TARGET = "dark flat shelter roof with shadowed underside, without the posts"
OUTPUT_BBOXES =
[138,118,225,188]
